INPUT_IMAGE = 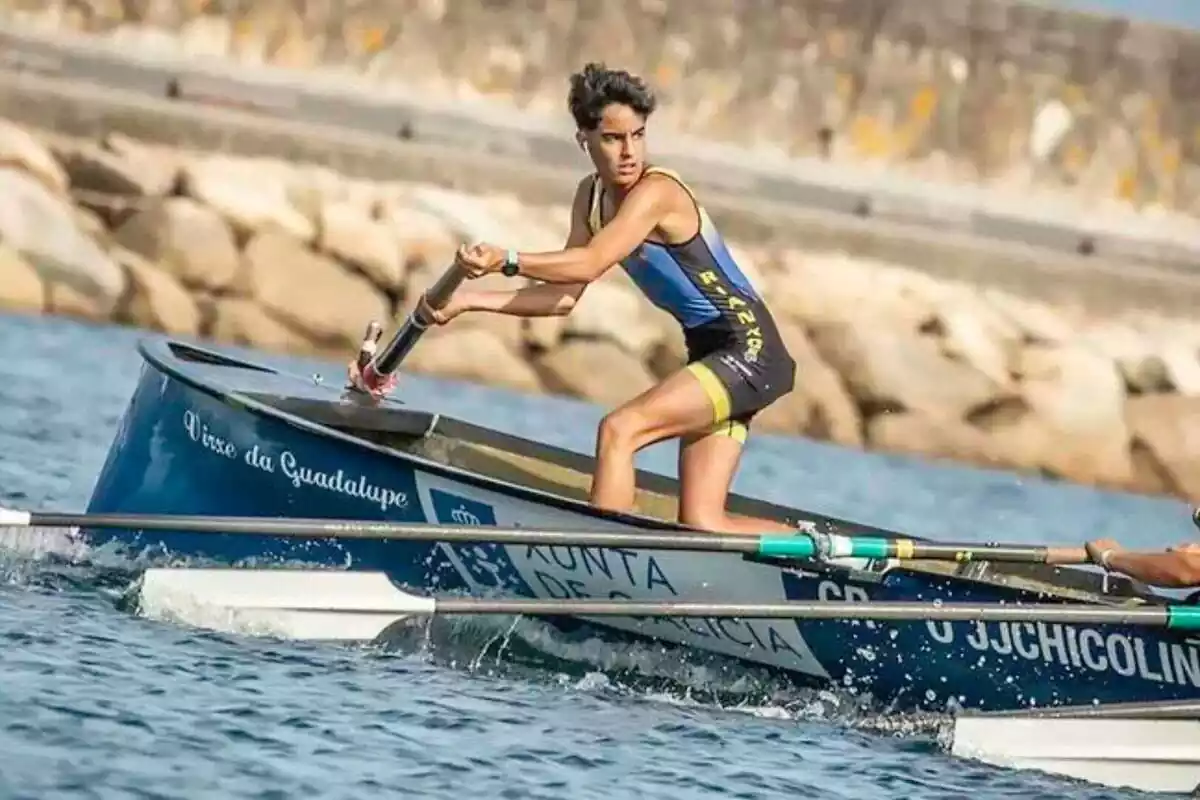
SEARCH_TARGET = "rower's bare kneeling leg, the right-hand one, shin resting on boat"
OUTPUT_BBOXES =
[679,423,796,535]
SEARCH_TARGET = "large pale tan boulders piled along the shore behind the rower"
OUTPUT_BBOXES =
[0,121,1200,500]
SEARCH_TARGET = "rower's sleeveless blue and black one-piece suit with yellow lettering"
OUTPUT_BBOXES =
[588,167,796,441]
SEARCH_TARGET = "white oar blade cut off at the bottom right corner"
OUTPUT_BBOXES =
[952,715,1200,793]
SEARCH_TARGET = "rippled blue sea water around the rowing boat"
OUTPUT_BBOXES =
[0,315,1192,800]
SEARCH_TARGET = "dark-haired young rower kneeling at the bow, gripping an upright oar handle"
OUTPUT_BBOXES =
[350,64,796,534]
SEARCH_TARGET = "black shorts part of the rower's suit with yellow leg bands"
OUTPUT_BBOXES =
[684,316,796,441]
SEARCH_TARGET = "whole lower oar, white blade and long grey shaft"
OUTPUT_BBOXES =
[131,567,1200,640]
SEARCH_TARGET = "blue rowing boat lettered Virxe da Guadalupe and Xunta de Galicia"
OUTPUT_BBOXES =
[82,339,1200,710]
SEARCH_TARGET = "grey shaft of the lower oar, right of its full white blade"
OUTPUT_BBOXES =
[424,597,1200,630]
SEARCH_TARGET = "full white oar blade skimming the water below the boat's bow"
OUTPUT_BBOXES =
[139,569,436,642]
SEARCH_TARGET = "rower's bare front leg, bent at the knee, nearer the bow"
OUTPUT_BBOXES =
[590,369,713,511]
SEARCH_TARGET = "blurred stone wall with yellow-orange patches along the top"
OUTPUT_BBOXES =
[0,0,1200,219]
